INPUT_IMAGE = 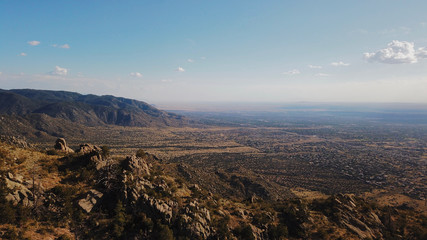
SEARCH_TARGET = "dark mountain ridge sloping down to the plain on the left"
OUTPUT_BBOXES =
[0,89,187,138]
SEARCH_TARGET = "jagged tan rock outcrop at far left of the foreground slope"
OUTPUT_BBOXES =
[5,174,34,206]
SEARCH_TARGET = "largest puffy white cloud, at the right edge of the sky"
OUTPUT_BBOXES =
[363,40,427,64]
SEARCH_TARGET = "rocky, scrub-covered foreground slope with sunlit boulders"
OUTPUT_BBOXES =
[0,139,427,239]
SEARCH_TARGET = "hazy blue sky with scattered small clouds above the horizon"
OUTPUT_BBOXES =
[0,0,427,103]
